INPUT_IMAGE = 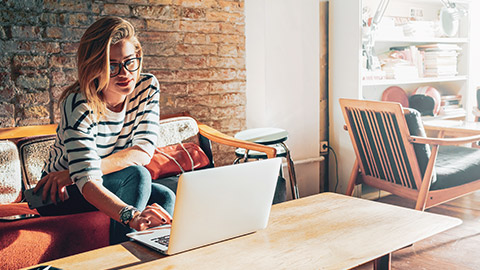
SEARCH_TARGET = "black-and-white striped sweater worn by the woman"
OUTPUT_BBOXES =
[43,74,160,191]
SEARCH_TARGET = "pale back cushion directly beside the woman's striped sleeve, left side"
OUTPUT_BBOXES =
[17,135,55,189]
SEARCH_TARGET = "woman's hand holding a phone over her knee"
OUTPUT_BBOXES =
[33,170,73,204]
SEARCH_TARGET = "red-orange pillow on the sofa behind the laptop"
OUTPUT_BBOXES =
[145,143,210,179]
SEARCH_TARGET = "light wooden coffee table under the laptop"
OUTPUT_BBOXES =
[26,193,462,269]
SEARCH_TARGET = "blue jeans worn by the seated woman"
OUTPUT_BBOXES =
[37,166,175,245]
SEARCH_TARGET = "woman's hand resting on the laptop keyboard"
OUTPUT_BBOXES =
[129,203,172,231]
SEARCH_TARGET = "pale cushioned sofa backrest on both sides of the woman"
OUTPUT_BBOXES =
[0,116,201,204]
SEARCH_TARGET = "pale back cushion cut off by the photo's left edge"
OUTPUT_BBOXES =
[0,141,22,204]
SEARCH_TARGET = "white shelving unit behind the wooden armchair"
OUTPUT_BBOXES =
[329,0,476,195]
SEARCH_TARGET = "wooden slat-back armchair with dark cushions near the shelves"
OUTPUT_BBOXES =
[340,99,480,211]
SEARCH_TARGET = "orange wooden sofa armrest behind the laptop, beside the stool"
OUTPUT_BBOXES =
[197,122,277,158]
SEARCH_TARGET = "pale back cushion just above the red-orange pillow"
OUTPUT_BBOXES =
[157,116,198,147]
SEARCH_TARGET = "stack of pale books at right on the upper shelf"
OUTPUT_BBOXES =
[417,43,461,77]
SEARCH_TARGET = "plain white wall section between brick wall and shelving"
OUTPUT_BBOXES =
[245,0,320,196]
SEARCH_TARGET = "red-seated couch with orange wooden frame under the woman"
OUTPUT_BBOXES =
[0,114,286,269]
